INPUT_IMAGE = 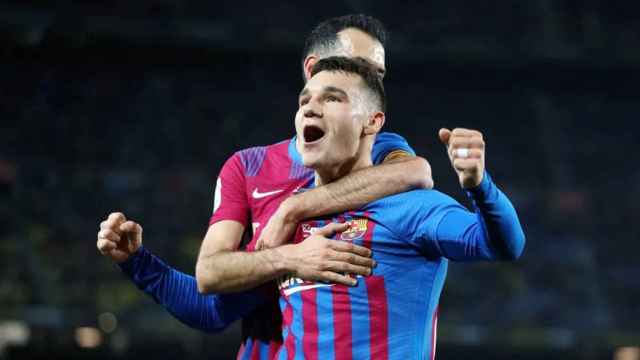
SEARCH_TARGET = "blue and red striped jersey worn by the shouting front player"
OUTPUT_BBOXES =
[277,174,524,360]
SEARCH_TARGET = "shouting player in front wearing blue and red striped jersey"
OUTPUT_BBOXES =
[270,57,525,359]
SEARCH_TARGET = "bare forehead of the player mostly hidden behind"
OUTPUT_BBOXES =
[338,28,385,70]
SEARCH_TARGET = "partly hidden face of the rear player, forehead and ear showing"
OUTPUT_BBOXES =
[304,28,386,80]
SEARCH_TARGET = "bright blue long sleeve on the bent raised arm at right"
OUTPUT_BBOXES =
[398,173,525,261]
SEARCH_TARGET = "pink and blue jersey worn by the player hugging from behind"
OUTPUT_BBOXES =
[209,133,415,359]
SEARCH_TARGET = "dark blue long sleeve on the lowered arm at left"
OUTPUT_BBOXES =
[119,247,264,332]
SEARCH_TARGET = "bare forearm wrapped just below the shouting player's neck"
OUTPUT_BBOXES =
[282,157,433,222]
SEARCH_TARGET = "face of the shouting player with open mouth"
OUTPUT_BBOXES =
[296,71,369,171]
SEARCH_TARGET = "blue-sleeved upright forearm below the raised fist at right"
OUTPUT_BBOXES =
[467,172,525,260]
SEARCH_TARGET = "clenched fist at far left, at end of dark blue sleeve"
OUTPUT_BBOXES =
[97,212,142,262]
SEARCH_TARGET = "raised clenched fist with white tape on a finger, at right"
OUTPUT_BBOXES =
[438,128,484,189]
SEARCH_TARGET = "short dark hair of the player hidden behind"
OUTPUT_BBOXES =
[302,14,388,68]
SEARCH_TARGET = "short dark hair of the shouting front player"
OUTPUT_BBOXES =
[311,56,387,112]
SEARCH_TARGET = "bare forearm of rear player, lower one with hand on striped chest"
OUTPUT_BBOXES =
[196,248,290,293]
